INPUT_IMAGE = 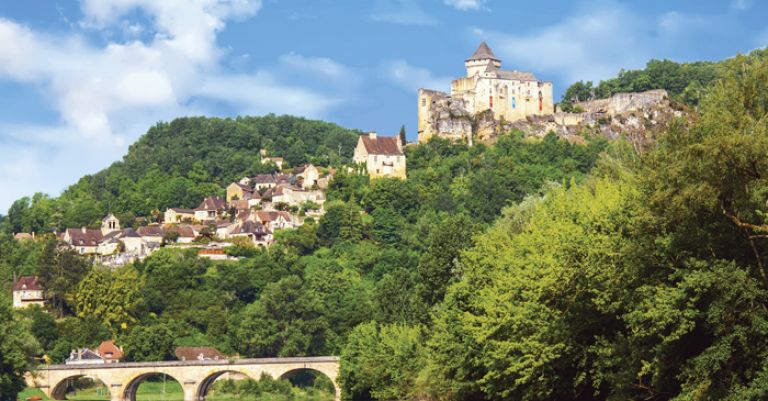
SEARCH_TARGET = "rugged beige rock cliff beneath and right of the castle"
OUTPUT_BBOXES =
[431,90,688,149]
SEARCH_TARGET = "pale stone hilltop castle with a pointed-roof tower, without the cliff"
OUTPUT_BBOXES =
[418,42,554,144]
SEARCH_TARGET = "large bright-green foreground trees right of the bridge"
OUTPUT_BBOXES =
[342,50,768,401]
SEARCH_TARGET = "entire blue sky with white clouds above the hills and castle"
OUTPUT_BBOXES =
[0,0,768,210]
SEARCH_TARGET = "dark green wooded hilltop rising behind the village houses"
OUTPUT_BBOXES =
[2,115,359,232]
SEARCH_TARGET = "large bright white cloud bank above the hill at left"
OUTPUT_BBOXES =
[0,0,352,209]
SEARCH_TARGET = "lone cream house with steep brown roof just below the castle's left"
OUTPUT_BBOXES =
[353,132,406,179]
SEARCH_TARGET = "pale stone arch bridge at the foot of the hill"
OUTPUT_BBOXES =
[27,356,341,401]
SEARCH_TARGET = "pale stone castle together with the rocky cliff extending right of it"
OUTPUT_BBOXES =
[418,42,684,145]
